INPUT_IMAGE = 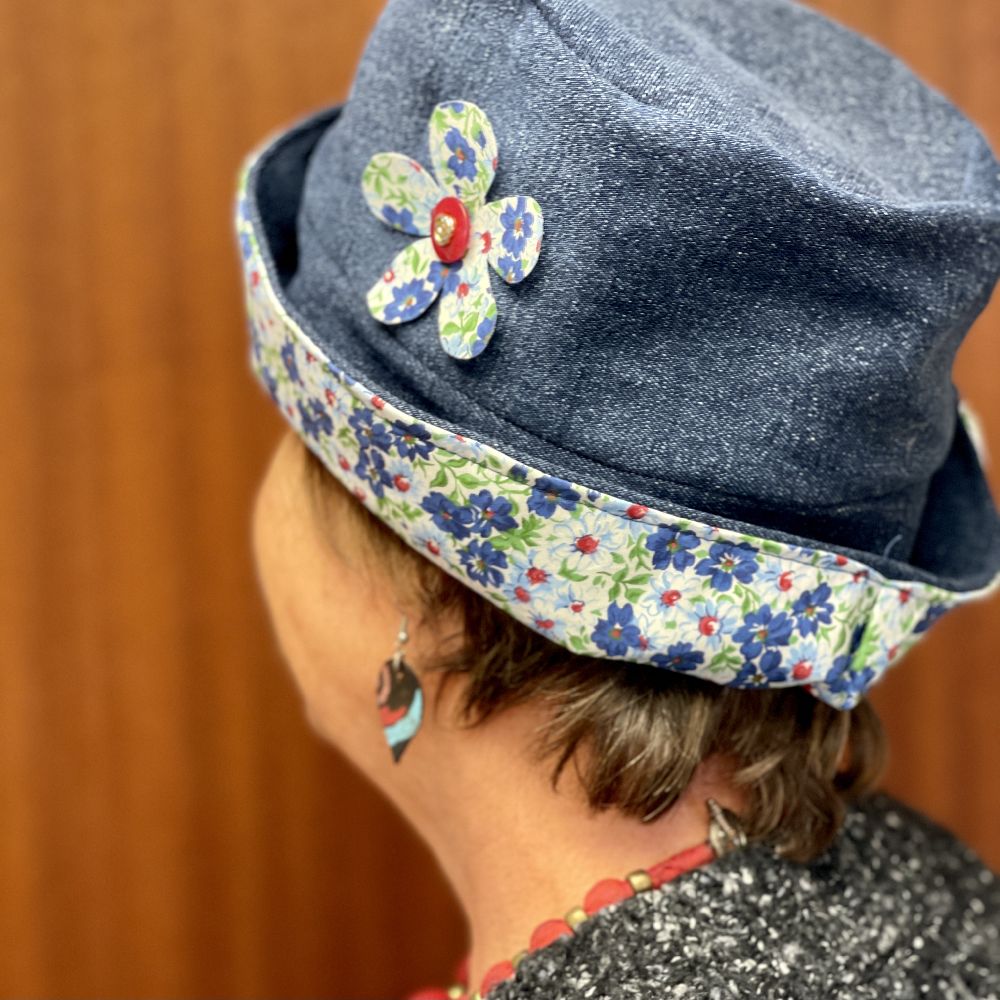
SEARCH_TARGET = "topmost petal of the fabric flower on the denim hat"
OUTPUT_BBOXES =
[428,101,497,207]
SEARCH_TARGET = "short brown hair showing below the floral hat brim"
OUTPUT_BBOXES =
[302,444,886,861]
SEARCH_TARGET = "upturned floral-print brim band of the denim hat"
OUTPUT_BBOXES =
[236,144,985,709]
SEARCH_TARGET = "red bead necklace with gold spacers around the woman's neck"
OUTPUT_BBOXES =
[407,799,747,1000]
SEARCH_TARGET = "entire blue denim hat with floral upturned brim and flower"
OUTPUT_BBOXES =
[236,0,1000,708]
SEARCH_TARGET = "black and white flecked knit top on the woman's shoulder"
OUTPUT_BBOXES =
[488,793,1000,1000]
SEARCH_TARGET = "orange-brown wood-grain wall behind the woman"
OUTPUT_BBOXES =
[0,0,1000,1000]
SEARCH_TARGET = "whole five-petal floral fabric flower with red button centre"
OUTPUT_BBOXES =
[361,101,542,360]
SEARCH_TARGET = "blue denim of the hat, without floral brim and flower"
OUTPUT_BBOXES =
[260,0,1000,591]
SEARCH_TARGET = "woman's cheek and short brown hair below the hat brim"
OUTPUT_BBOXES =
[255,433,884,859]
